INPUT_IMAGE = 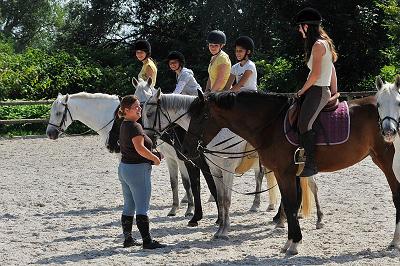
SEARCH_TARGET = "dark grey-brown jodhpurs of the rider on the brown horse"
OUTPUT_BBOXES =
[298,86,331,134]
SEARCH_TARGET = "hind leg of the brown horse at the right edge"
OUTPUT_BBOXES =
[370,143,400,250]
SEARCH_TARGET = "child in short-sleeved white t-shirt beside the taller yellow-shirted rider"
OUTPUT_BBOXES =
[225,36,257,92]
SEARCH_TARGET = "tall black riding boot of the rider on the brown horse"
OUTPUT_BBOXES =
[299,130,318,177]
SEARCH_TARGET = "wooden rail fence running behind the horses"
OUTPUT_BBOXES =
[0,91,376,125]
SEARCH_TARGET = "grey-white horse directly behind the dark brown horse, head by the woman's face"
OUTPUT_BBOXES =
[142,90,277,239]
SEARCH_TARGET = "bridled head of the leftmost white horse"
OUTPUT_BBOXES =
[46,93,73,139]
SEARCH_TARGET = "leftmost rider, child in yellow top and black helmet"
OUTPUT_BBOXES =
[135,40,157,87]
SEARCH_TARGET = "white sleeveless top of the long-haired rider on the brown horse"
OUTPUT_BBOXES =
[307,40,333,87]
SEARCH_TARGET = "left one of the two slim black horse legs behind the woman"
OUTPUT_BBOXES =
[185,162,203,227]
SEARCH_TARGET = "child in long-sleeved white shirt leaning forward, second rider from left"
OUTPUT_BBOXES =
[167,51,202,95]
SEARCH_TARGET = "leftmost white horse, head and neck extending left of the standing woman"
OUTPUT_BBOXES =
[46,92,194,216]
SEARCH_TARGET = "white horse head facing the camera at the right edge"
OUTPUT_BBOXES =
[376,75,400,143]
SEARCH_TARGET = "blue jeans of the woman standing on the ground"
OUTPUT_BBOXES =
[118,162,151,216]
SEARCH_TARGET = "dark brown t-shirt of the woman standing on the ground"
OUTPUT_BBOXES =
[119,120,153,164]
